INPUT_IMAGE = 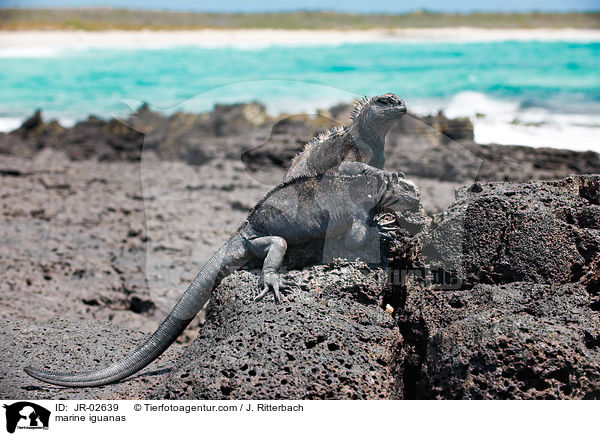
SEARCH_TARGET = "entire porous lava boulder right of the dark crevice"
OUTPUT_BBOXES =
[392,176,600,399]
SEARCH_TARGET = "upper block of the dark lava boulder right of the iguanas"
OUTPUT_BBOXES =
[421,176,600,287]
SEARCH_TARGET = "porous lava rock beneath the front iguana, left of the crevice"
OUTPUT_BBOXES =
[153,261,401,399]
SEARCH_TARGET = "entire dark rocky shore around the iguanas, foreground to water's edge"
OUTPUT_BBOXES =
[0,103,600,399]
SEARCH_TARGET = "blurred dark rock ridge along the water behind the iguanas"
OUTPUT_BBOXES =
[0,102,600,183]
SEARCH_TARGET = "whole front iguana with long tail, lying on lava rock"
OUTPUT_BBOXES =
[25,162,420,387]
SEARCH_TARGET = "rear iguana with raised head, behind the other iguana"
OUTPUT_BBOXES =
[284,93,406,181]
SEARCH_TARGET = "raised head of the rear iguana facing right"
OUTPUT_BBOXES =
[352,93,406,133]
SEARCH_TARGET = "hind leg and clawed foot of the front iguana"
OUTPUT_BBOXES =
[248,236,296,303]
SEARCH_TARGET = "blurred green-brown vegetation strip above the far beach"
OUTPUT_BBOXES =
[0,8,600,30]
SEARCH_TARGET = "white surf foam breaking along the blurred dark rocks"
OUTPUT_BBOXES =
[0,91,600,153]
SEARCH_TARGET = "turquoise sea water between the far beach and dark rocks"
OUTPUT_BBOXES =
[0,41,600,150]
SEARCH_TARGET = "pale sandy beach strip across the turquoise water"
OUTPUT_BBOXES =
[0,27,600,52]
